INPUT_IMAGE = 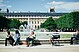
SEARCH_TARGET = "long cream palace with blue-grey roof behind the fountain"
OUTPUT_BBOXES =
[4,12,66,29]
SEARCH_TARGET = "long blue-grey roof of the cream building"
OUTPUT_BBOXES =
[3,12,67,16]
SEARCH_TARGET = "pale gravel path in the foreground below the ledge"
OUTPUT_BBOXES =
[0,44,79,52]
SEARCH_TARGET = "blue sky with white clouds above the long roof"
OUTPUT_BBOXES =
[0,0,79,12]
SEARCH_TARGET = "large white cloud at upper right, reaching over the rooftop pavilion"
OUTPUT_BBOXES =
[45,1,79,12]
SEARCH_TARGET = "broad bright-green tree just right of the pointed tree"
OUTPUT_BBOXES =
[56,14,73,29]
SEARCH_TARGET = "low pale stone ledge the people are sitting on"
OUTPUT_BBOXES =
[0,38,70,44]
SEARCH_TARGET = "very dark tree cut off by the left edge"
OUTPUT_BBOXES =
[0,14,10,30]
